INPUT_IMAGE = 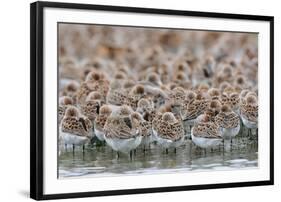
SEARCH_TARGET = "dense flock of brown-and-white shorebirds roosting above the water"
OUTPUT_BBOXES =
[58,24,258,158]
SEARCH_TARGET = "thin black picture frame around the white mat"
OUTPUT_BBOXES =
[30,2,274,200]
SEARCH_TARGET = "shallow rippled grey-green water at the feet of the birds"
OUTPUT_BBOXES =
[58,137,258,178]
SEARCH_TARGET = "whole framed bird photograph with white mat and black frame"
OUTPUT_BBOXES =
[30,2,274,200]
